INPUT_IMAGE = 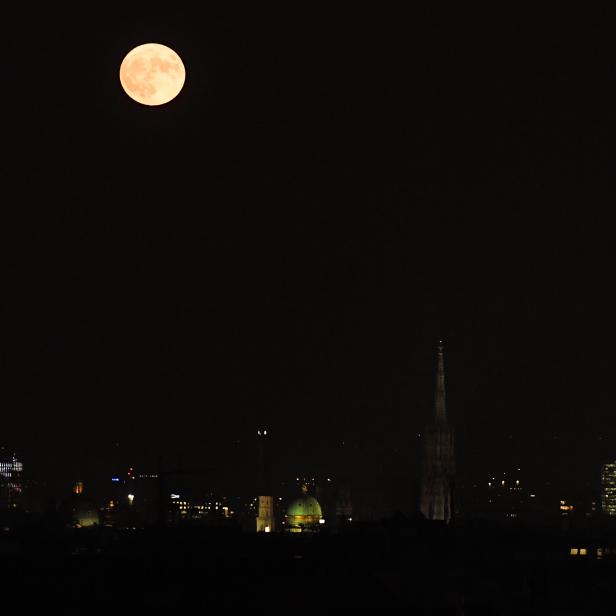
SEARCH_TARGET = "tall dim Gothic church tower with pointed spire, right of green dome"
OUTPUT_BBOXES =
[419,341,455,522]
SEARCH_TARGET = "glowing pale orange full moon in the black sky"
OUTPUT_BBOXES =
[120,43,186,105]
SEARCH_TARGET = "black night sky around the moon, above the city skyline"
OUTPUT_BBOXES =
[0,2,616,500]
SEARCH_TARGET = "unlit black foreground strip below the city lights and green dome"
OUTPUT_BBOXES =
[0,520,616,615]
